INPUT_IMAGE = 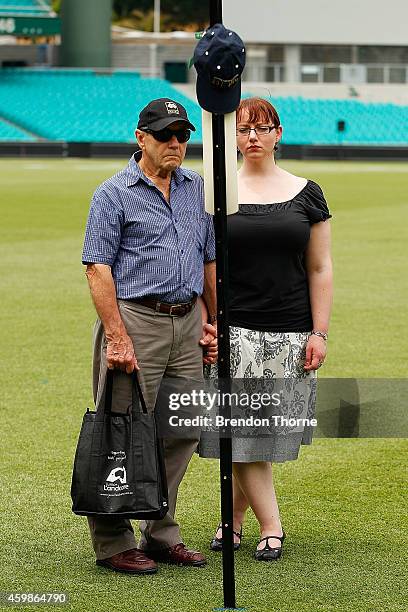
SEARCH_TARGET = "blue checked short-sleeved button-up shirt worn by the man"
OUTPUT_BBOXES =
[82,153,215,304]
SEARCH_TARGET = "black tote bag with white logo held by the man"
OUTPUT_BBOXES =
[71,370,168,519]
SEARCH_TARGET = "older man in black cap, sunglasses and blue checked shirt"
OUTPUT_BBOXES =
[82,98,216,574]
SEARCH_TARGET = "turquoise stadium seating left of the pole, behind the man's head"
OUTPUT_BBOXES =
[0,69,201,142]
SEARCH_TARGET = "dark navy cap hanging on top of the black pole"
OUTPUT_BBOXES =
[193,23,246,115]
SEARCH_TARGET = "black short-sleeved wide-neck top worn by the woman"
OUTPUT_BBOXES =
[228,180,331,332]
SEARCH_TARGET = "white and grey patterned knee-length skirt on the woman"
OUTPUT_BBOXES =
[198,326,316,463]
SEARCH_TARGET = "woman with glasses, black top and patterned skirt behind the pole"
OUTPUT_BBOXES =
[199,98,332,561]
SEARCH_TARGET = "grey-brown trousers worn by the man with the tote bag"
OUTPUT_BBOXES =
[88,300,203,559]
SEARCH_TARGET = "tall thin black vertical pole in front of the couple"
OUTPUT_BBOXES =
[210,0,235,608]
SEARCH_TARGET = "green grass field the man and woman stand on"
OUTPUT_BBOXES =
[0,159,408,612]
